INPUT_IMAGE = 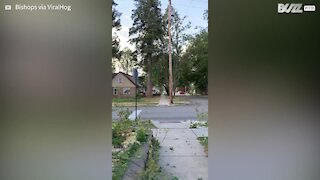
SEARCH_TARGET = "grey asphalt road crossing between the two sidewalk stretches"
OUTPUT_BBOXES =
[112,96,208,121]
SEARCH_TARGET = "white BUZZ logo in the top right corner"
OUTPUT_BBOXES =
[278,3,316,14]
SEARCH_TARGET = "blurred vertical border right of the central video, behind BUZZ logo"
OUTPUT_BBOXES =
[209,0,320,180]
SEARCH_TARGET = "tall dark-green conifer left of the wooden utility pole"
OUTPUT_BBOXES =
[129,0,164,97]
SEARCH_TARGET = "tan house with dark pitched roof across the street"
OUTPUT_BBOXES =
[112,72,141,97]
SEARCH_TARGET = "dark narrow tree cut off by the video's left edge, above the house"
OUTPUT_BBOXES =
[112,1,121,59]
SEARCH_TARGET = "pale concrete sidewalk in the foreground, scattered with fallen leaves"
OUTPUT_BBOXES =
[152,121,208,180]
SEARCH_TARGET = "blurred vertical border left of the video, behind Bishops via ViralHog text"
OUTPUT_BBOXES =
[0,0,112,180]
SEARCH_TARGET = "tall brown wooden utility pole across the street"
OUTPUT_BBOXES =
[168,0,173,105]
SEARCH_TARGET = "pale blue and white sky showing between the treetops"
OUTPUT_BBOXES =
[115,0,208,50]
